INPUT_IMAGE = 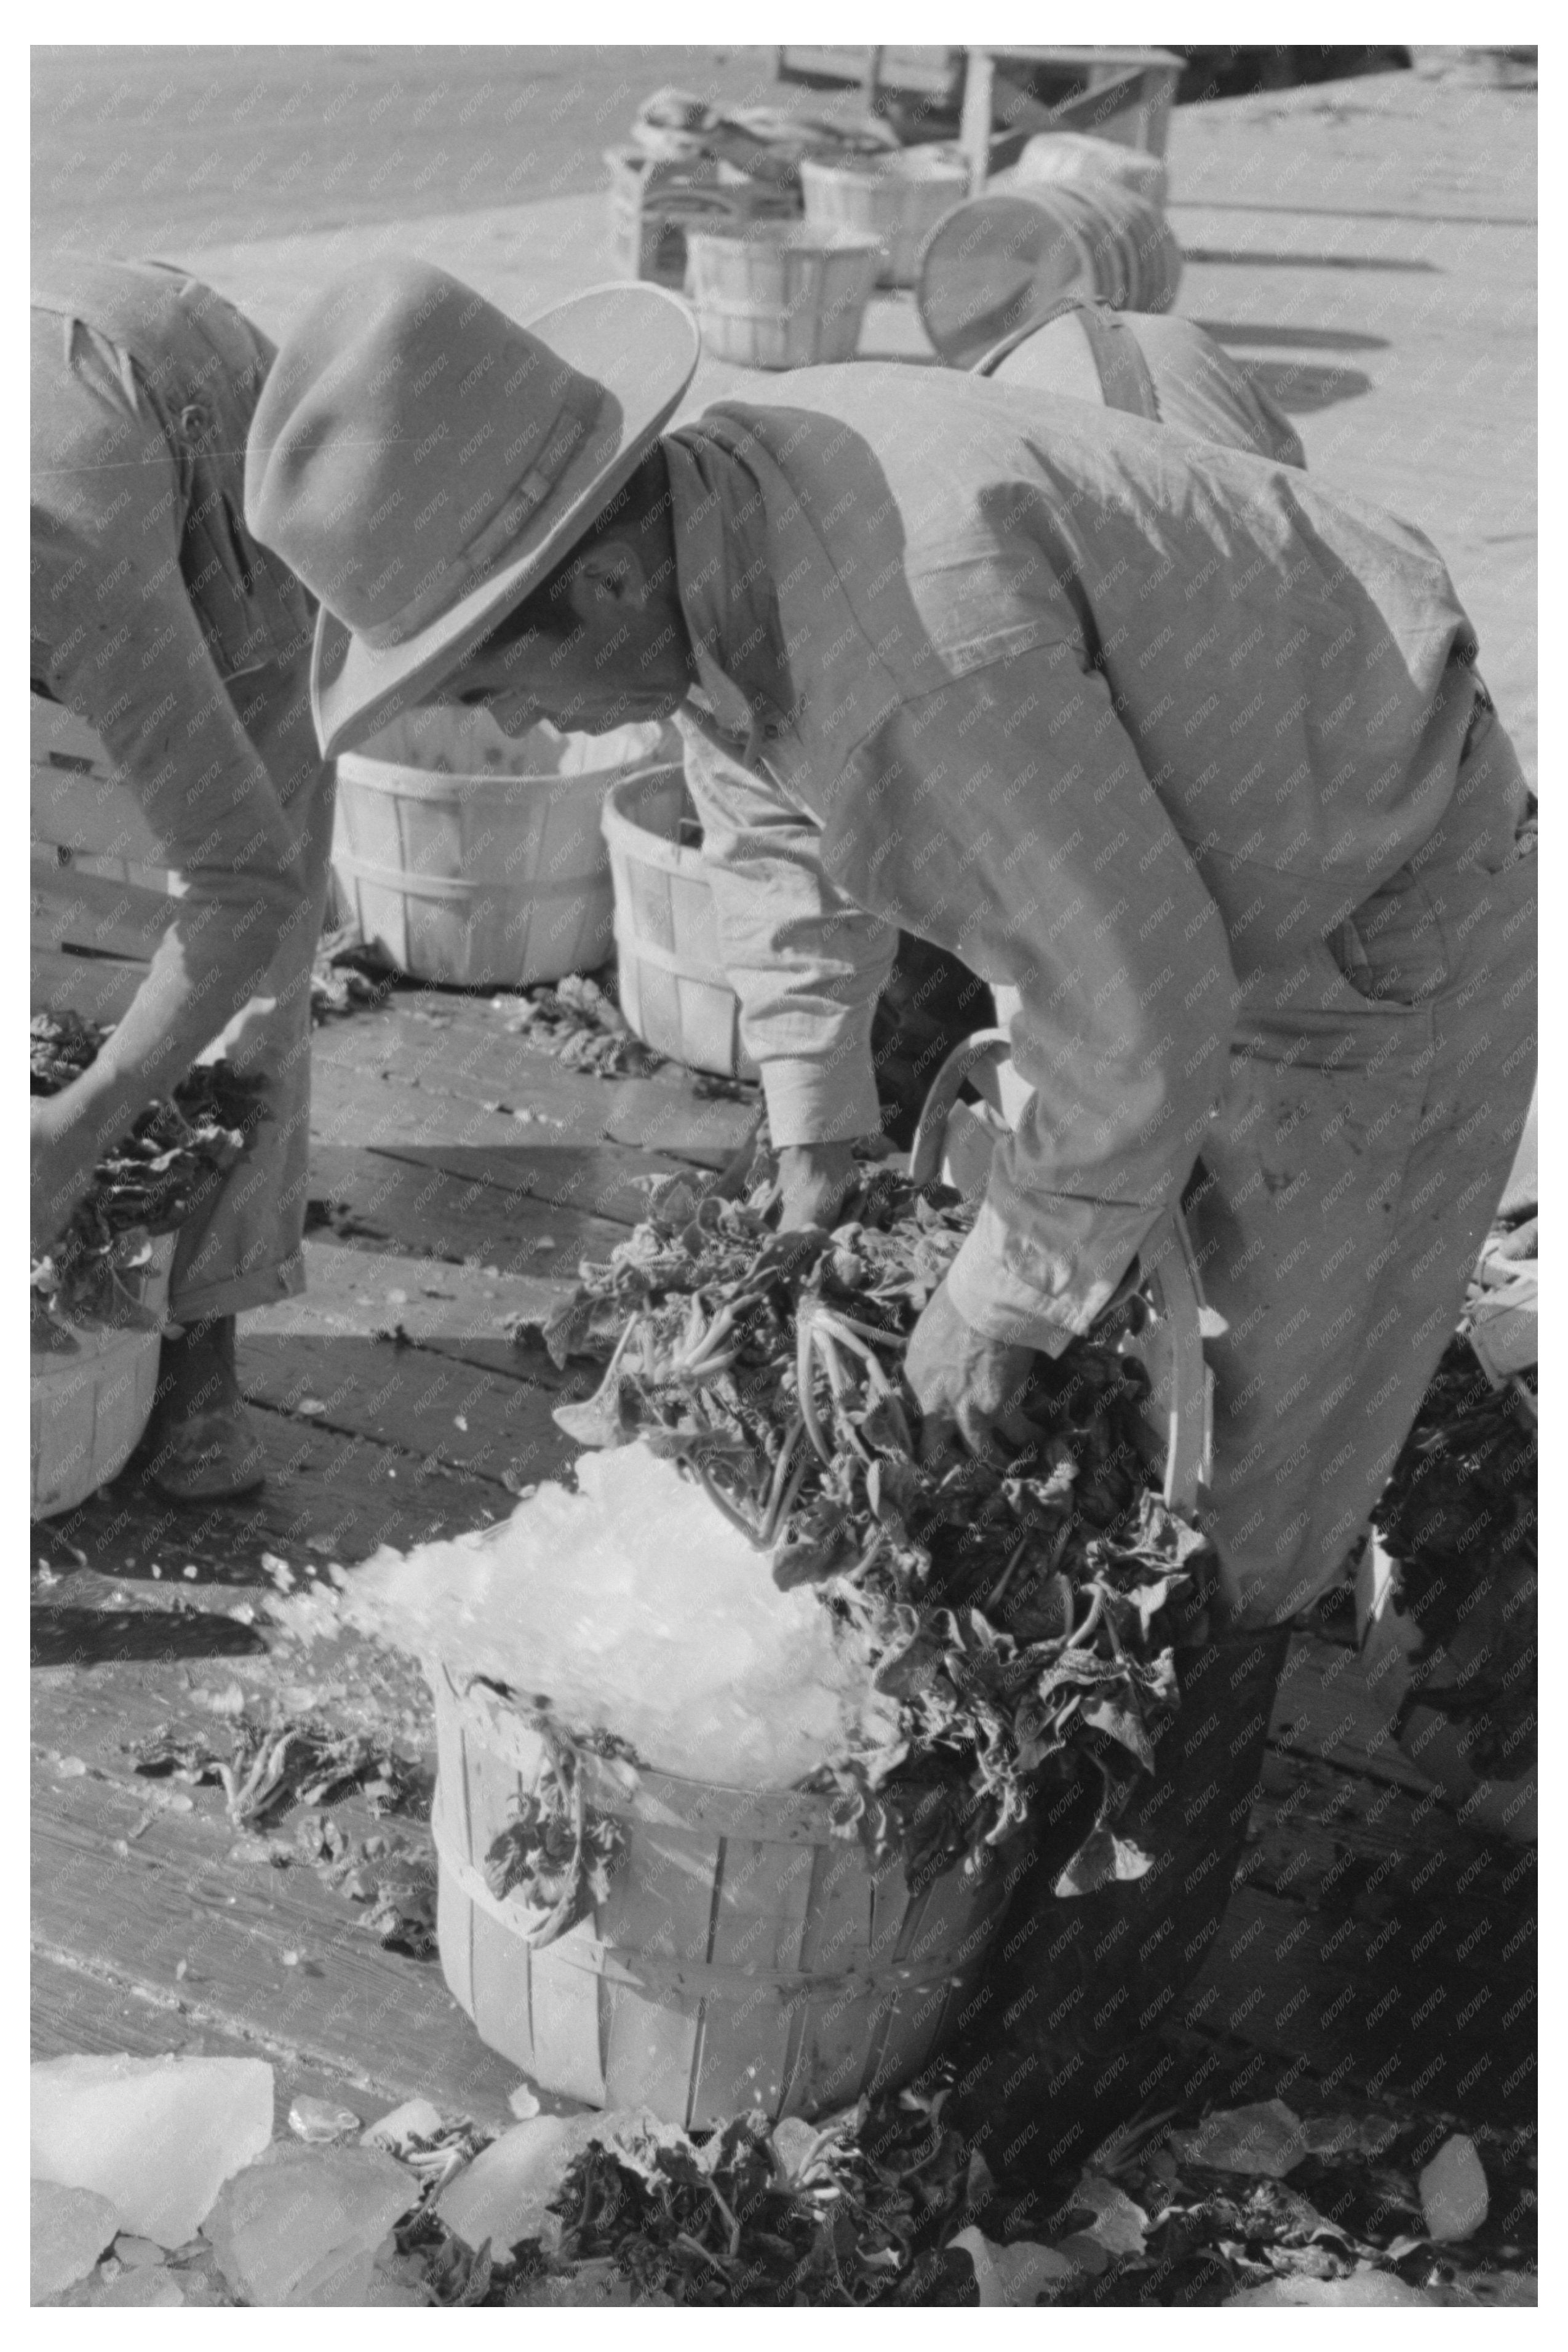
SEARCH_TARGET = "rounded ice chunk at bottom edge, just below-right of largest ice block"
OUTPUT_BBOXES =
[202,2140,418,2305]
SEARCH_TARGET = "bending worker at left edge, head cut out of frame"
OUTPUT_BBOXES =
[31,257,332,1503]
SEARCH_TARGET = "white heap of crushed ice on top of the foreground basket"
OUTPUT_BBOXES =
[343,1444,896,1787]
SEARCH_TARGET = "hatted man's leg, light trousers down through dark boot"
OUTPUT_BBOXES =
[955,701,1535,2173]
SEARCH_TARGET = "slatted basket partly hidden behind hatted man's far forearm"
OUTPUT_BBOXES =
[602,769,757,1077]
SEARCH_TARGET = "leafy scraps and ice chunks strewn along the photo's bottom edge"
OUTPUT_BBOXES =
[42,2091,1535,2307]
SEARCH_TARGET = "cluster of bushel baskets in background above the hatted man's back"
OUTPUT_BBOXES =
[607,89,1180,369]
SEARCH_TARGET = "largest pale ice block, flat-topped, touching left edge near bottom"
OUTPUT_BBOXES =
[33,2058,273,2246]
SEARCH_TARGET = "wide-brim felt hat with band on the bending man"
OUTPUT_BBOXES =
[244,261,701,757]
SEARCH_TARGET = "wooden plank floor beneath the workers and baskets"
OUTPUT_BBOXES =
[33,75,1535,2154]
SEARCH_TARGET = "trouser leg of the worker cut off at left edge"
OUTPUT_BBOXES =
[169,658,334,1322]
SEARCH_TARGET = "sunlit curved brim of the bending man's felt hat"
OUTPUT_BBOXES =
[310,285,701,760]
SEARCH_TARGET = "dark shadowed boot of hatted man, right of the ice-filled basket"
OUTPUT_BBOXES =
[947,1628,1288,2183]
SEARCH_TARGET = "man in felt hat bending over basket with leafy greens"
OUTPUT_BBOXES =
[247,263,1533,2164]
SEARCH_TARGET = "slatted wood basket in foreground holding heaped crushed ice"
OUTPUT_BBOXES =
[432,1668,1006,2129]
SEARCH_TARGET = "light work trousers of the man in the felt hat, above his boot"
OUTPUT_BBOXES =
[1187,722,1535,1623]
